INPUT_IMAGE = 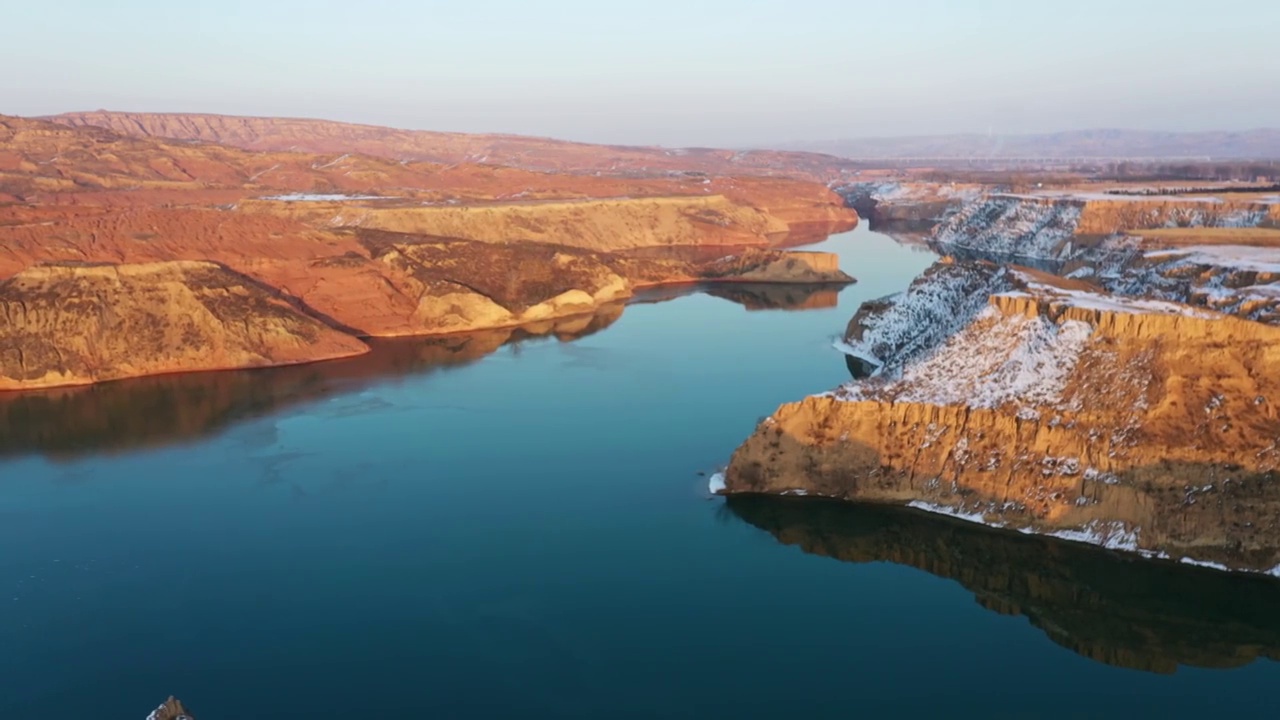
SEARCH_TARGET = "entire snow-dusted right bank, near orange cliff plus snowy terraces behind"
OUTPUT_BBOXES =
[716,183,1280,575]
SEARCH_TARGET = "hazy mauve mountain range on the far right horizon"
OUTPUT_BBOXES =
[781,129,1280,159]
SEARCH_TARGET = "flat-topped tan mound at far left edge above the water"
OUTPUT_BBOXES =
[0,261,367,389]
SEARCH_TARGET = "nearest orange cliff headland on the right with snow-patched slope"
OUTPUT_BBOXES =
[724,266,1280,571]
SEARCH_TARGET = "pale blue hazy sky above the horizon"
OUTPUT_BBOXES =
[0,0,1280,146]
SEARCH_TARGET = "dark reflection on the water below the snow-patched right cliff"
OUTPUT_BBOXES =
[726,496,1280,673]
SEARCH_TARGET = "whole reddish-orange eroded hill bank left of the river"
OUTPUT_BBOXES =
[0,114,858,389]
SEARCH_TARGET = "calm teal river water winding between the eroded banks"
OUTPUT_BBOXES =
[0,222,1280,720]
